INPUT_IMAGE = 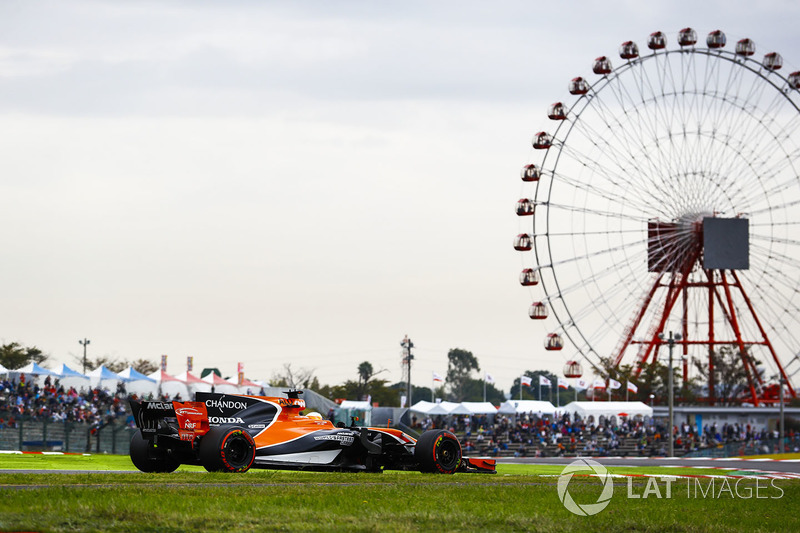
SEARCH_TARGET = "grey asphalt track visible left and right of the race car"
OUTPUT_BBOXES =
[0,457,800,474]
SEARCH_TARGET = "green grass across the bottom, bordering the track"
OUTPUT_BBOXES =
[0,455,800,532]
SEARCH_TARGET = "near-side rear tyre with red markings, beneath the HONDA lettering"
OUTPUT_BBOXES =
[200,426,256,472]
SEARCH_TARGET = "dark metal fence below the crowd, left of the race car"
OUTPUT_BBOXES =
[0,419,135,455]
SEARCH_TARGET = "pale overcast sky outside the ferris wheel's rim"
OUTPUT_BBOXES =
[0,0,800,390]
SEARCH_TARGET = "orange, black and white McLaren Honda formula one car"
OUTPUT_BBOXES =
[130,391,495,474]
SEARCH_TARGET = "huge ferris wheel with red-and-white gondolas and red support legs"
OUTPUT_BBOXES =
[514,28,800,405]
